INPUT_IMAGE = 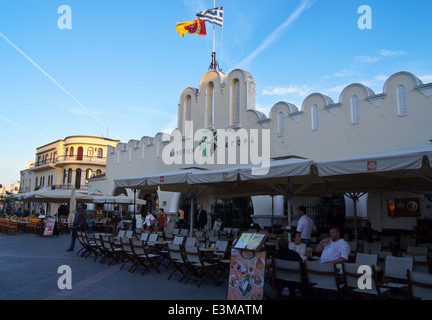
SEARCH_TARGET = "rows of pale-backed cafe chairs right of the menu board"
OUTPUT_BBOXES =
[273,234,432,300]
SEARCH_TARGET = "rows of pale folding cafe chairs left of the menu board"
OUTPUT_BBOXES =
[76,229,233,287]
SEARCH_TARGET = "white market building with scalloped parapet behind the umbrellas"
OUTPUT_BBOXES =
[89,69,432,229]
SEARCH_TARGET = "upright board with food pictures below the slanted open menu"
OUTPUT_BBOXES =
[228,248,266,300]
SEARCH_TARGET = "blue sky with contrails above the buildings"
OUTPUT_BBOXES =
[0,0,432,185]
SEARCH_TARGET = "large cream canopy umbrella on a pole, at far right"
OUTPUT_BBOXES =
[303,144,432,239]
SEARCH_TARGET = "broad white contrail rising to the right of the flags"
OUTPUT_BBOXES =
[234,0,314,69]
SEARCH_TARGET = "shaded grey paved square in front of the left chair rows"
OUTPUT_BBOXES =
[0,234,228,300]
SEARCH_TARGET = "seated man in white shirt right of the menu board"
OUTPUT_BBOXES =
[316,227,351,264]
